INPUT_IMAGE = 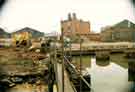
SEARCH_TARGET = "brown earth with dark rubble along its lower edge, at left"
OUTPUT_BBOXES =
[0,48,48,87]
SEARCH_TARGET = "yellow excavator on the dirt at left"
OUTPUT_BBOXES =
[12,32,32,47]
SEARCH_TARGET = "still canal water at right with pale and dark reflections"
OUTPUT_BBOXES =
[73,54,135,92]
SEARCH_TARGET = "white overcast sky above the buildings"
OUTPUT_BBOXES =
[0,0,135,33]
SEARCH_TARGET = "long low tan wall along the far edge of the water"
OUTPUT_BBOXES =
[58,42,135,55]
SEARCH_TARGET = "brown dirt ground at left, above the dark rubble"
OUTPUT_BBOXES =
[0,48,46,75]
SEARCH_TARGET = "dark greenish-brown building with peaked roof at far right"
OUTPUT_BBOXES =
[101,20,135,42]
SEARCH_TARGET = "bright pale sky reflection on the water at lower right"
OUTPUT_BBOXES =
[91,59,129,92]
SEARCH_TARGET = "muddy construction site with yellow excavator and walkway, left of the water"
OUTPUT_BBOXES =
[0,29,90,92]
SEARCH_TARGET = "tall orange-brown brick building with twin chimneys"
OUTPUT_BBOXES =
[61,13,90,36]
